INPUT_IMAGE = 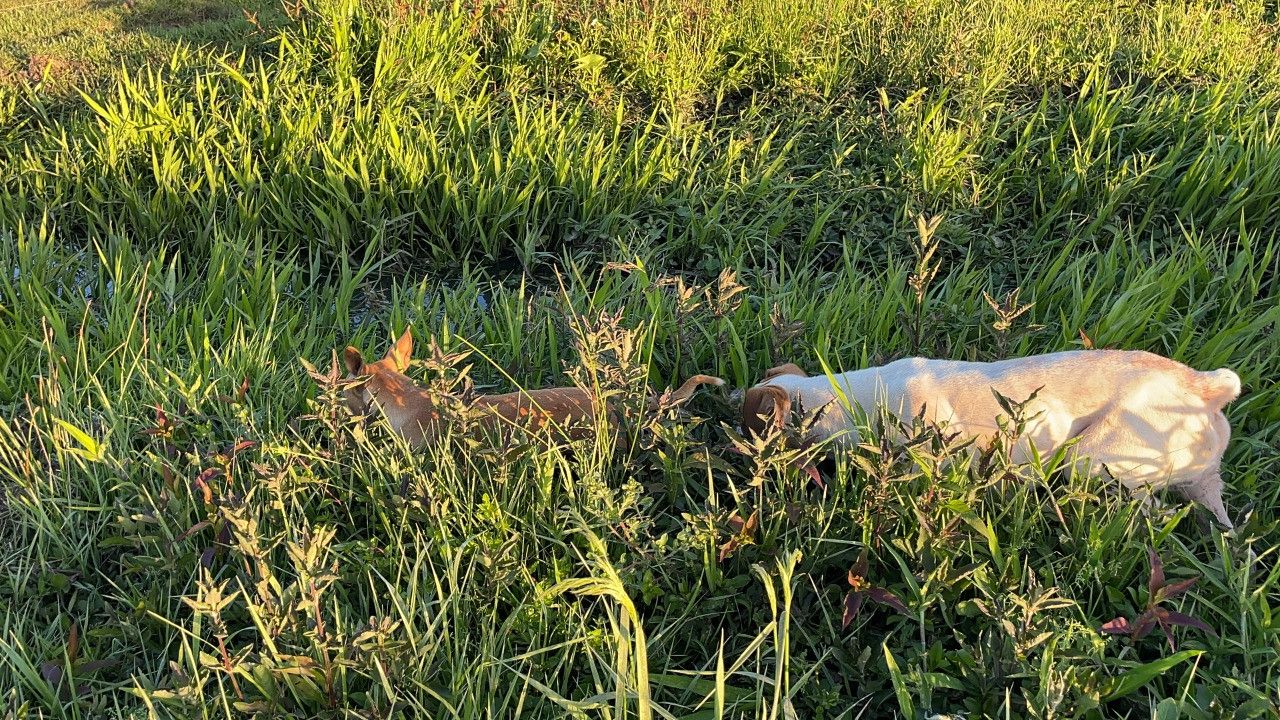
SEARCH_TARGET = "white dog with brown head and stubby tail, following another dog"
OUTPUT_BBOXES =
[742,350,1240,520]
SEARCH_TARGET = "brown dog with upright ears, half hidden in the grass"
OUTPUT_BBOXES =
[343,329,724,447]
